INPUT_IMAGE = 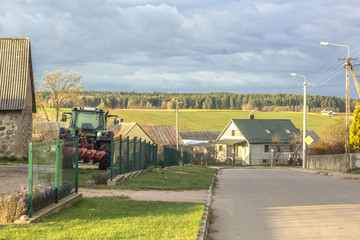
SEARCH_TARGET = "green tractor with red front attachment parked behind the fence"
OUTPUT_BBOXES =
[59,107,119,170]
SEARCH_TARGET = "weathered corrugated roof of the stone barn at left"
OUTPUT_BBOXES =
[0,38,36,113]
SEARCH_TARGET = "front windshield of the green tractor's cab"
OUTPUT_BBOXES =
[71,111,104,129]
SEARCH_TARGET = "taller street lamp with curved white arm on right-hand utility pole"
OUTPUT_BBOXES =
[320,42,350,156]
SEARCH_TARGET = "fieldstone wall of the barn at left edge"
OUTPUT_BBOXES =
[0,111,23,158]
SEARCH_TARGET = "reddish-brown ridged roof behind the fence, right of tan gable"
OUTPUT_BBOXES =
[143,126,183,146]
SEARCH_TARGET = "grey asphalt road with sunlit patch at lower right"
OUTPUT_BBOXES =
[209,169,360,240]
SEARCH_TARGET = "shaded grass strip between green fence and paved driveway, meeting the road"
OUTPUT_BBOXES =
[79,166,216,190]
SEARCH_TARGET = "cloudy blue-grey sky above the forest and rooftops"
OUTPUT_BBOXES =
[0,0,360,98]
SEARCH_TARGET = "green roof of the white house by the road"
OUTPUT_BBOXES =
[231,119,300,143]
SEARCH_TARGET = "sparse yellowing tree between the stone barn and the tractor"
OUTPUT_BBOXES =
[41,70,84,121]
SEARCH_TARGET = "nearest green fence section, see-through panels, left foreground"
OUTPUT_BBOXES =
[29,138,79,217]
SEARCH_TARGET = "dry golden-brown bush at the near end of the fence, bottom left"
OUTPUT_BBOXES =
[0,185,28,223]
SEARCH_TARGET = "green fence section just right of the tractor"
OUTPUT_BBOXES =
[110,136,157,180]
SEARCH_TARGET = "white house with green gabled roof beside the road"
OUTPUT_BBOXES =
[215,115,302,165]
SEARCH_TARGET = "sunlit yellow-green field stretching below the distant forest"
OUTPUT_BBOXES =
[38,109,335,136]
